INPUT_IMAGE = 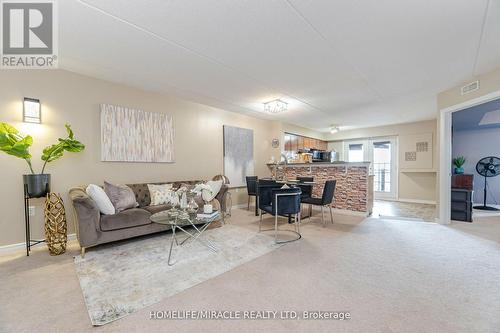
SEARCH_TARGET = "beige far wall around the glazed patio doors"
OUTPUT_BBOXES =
[328,120,438,202]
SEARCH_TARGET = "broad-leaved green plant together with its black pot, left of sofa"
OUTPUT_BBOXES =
[0,123,85,198]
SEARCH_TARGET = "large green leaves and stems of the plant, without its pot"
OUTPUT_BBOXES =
[0,123,85,174]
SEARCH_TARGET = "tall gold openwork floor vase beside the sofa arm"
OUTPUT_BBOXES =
[45,193,68,256]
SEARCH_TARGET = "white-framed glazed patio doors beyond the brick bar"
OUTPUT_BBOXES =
[344,137,398,199]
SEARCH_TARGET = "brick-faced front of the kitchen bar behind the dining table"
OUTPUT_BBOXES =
[268,162,373,213]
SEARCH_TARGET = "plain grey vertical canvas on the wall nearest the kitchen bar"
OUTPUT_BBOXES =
[224,125,254,187]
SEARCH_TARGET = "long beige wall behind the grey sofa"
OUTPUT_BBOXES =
[0,70,282,246]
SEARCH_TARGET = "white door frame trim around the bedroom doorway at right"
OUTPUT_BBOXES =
[439,91,500,224]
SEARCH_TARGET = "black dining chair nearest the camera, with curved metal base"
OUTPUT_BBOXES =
[259,184,302,244]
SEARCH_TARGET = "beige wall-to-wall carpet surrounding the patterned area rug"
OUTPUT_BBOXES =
[0,206,500,332]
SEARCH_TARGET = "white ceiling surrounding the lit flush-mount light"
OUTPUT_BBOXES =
[58,0,500,131]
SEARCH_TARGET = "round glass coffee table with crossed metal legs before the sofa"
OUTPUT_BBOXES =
[150,210,221,266]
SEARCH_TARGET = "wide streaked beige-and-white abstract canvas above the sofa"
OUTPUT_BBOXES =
[101,104,174,163]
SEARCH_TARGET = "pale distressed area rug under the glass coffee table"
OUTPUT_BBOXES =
[75,225,279,326]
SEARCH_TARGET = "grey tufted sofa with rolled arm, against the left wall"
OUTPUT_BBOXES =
[69,181,228,257]
